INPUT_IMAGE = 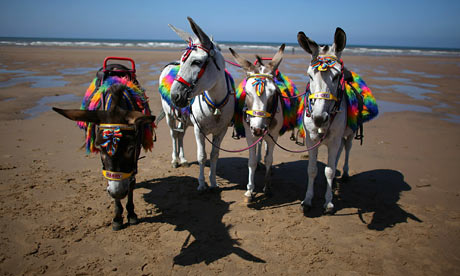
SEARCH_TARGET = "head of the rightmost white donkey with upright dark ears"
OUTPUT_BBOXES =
[297,28,347,128]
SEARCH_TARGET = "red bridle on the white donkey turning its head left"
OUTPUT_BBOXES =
[174,38,220,101]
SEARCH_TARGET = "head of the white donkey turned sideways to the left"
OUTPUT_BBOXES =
[169,17,225,107]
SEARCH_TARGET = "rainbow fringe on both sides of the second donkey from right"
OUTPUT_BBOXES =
[233,73,305,137]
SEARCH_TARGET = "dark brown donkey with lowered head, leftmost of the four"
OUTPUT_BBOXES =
[53,82,155,231]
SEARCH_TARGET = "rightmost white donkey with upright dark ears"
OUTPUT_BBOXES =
[297,28,354,213]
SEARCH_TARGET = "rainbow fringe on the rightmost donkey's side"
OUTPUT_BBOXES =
[345,72,379,131]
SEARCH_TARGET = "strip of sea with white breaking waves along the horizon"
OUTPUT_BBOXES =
[0,37,460,57]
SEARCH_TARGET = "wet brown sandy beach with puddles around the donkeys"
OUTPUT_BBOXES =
[0,46,460,275]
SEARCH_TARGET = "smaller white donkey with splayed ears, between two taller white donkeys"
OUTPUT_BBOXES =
[229,44,285,202]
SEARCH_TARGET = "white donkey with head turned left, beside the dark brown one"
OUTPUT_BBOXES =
[167,17,235,191]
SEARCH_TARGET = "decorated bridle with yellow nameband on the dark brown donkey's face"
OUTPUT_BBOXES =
[99,124,140,181]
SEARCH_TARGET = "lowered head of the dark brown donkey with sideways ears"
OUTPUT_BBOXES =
[53,85,155,199]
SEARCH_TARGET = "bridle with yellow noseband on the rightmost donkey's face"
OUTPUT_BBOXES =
[305,56,344,117]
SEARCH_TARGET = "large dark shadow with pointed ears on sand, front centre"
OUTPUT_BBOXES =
[136,176,265,266]
